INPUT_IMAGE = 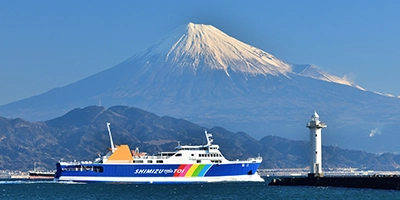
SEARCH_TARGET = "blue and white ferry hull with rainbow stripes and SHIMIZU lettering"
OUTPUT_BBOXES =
[55,161,264,183]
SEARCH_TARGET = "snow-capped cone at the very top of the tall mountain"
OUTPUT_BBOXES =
[140,23,291,76]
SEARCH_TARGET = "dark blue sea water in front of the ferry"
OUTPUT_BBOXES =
[0,178,400,200]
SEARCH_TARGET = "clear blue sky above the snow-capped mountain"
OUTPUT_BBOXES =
[0,0,400,105]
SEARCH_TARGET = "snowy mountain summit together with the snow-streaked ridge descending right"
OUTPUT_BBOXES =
[129,23,364,90]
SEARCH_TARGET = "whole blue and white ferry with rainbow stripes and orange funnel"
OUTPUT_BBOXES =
[55,123,264,183]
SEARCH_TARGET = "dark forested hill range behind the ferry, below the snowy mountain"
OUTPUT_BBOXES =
[0,106,400,170]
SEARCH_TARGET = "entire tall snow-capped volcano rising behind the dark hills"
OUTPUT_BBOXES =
[0,23,400,152]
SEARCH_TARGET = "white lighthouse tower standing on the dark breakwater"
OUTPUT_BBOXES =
[307,112,326,177]
